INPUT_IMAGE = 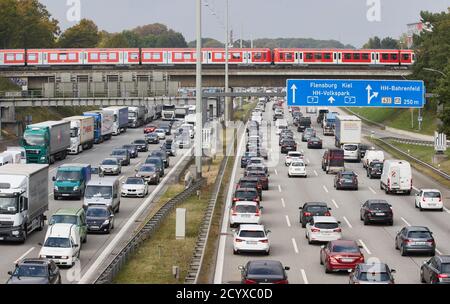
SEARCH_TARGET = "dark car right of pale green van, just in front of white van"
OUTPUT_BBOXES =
[86,205,114,233]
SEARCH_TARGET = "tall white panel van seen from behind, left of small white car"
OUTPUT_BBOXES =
[380,160,412,195]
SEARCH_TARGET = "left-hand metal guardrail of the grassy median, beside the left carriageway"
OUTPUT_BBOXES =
[94,179,204,284]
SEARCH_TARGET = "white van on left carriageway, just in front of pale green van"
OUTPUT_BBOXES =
[39,224,81,266]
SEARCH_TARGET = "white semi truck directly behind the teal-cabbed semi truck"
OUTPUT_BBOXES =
[63,116,95,154]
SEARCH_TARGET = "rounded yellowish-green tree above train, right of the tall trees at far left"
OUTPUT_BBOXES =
[58,19,100,48]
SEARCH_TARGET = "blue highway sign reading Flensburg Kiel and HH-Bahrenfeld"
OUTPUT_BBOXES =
[286,79,425,108]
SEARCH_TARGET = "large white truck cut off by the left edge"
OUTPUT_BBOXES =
[0,164,49,242]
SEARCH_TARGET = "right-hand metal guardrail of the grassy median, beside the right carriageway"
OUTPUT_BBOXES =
[184,157,229,284]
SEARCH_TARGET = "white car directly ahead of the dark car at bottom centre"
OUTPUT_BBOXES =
[233,225,270,255]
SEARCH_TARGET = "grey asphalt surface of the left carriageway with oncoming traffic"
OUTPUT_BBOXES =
[0,121,187,284]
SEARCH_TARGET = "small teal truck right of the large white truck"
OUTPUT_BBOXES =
[53,164,91,200]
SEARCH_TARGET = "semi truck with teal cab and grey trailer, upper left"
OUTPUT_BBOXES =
[22,121,70,164]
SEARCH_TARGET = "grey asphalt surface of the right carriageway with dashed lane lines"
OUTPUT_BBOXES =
[215,103,450,284]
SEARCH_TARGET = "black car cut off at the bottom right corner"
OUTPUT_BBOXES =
[420,255,450,284]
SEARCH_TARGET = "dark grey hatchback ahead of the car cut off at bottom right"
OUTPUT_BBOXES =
[395,226,436,256]
